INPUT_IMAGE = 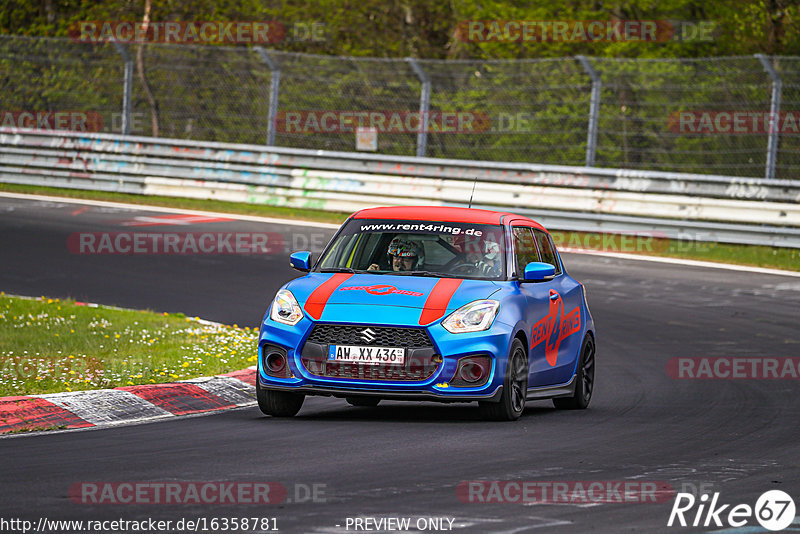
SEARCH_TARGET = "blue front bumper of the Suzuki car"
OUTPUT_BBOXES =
[258,318,512,402]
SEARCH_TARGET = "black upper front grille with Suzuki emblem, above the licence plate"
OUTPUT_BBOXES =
[308,324,433,349]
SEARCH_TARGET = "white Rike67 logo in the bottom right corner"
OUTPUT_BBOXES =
[667,490,795,531]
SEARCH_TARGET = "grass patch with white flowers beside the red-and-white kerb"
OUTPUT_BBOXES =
[0,294,258,397]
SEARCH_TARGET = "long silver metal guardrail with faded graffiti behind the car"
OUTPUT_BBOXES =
[0,128,800,248]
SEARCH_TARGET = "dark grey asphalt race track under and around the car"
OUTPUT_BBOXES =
[0,198,800,533]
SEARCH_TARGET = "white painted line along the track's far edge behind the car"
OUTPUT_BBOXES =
[0,191,800,278]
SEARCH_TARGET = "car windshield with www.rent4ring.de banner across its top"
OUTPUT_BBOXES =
[316,219,506,280]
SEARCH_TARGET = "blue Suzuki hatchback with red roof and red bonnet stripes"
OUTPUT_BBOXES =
[256,207,595,421]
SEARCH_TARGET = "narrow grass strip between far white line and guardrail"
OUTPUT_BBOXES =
[0,183,800,271]
